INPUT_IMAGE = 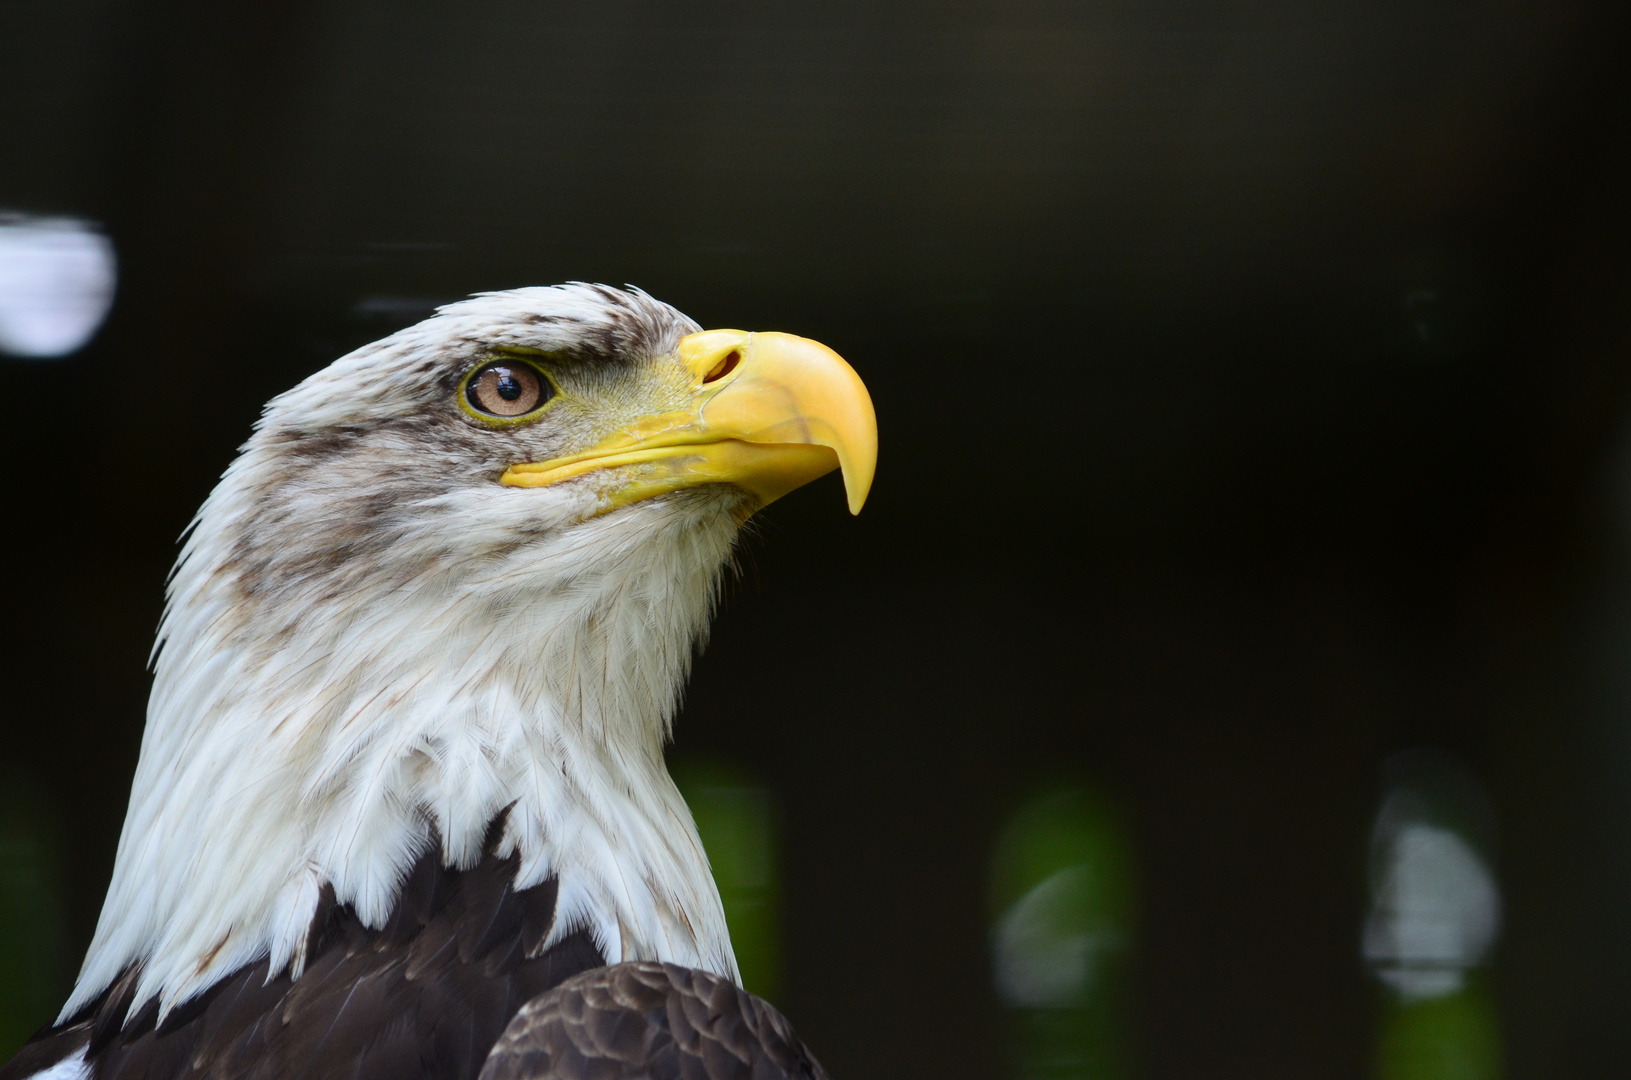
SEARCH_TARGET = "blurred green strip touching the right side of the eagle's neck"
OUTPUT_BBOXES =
[669,759,781,1002]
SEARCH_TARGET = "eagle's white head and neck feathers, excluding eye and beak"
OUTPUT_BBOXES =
[62,285,744,1018]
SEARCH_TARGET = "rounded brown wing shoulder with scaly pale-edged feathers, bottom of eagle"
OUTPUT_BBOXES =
[481,963,827,1080]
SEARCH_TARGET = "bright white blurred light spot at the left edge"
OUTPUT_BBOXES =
[0,214,117,359]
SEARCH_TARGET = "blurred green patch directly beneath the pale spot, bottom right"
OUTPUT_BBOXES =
[1377,982,1501,1080]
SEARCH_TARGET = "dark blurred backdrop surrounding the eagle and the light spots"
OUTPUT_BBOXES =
[0,0,1631,1080]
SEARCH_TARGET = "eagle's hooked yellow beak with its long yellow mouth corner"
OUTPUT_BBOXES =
[499,330,877,514]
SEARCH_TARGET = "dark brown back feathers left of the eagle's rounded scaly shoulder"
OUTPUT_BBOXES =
[0,830,605,1080]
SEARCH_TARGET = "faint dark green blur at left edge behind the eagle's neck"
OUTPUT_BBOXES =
[0,772,69,1060]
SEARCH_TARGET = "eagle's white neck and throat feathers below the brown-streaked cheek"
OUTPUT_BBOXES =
[62,440,737,1018]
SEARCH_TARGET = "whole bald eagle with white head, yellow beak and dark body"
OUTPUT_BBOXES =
[0,284,877,1080]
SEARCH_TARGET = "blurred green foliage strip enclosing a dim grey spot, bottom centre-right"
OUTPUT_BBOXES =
[992,788,1134,1080]
